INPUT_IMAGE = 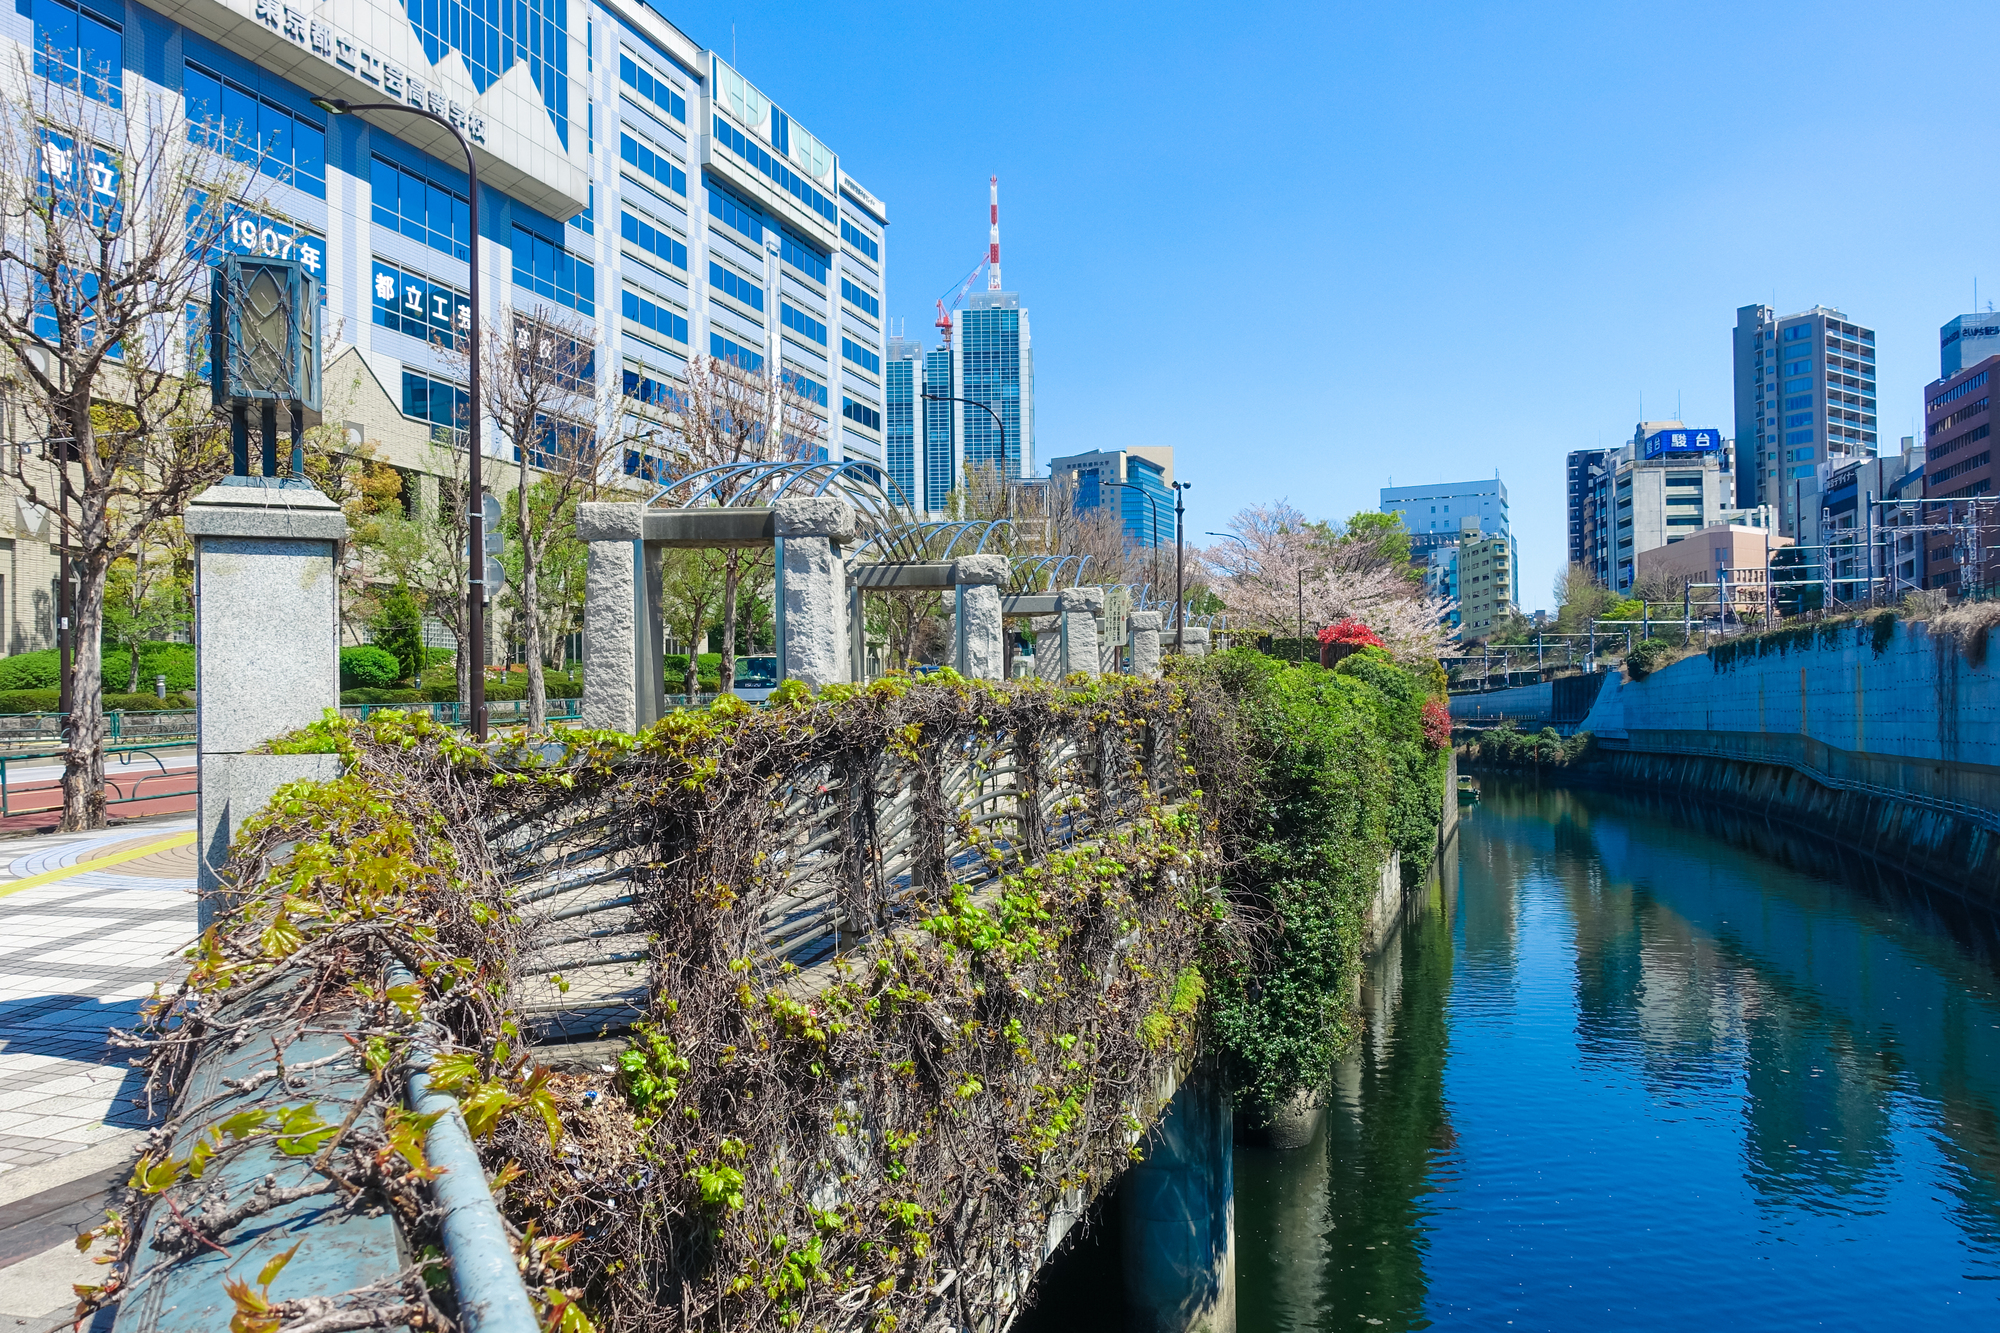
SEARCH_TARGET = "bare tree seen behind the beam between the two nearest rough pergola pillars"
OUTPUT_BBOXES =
[664,356,826,695]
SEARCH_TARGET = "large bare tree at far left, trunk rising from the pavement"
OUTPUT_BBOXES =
[0,62,250,831]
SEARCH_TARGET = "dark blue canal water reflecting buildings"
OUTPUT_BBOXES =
[1232,779,2000,1333]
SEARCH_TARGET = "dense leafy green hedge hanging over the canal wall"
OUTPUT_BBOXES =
[1176,648,1448,1119]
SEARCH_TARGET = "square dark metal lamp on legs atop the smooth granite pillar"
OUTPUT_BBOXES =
[208,254,320,486]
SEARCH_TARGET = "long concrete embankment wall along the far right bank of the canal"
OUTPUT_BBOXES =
[1512,622,2000,907]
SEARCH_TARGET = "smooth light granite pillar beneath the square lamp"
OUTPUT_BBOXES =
[186,476,348,931]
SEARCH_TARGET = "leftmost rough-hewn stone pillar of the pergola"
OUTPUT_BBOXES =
[576,502,666,731]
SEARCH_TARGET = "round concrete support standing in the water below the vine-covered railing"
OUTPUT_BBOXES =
[1118,1073,1236,1333]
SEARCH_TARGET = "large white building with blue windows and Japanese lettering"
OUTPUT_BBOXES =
[11,0,888,478]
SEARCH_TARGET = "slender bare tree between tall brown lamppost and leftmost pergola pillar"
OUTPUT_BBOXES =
[482,306,608,731]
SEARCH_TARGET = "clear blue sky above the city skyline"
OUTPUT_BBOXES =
[658,0,2000,608]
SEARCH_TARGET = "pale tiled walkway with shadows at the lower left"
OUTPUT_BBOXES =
[0,819,194,1333]
